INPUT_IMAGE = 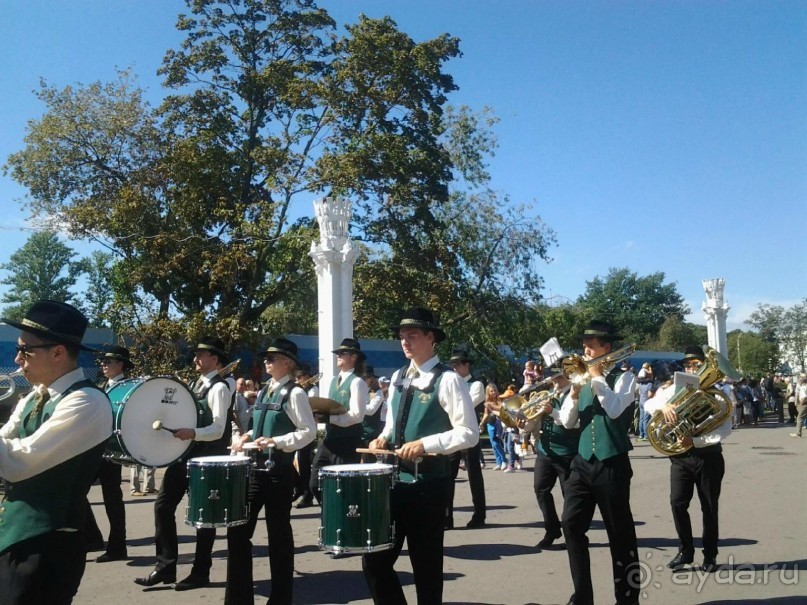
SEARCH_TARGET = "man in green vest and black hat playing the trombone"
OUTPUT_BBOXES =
[560,321,639,605]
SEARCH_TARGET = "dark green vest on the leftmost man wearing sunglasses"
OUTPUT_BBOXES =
[0,380,112,553]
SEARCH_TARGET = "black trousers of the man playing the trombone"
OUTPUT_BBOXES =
[563,453,639,605]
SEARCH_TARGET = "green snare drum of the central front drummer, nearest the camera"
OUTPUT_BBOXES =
[319,464,395,554]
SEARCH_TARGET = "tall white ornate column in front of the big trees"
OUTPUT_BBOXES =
[309,198,357,386]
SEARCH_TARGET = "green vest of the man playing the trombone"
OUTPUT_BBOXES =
[578,369,633,460]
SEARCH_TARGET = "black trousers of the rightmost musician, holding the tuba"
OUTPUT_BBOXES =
[670,447,726,558]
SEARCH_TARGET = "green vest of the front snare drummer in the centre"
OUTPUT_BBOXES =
[389,364,451,483]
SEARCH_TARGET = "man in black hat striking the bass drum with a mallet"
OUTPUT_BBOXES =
[135,336,233,590]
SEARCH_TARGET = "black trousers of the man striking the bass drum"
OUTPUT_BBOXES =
[154,462,216,578]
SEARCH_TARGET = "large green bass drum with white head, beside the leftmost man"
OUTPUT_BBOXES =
[106,377,199,467]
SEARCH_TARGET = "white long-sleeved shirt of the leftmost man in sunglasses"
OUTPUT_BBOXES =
[0,368,112,481]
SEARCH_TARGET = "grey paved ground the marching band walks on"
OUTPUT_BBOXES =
[76,421,807,605]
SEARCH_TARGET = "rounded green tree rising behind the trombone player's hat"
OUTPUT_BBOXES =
[577,268,689,347]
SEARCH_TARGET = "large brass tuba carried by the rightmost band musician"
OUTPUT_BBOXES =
[647,348,741,456]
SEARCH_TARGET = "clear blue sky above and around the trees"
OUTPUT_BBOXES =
[0,0,807,328]
